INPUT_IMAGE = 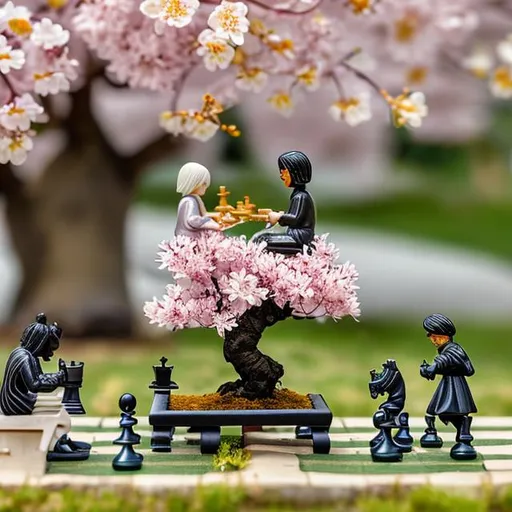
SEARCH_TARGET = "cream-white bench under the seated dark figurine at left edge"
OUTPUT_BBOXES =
[0,408,70,478]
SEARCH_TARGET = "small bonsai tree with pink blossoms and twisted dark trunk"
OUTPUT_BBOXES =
[144,232,360,399]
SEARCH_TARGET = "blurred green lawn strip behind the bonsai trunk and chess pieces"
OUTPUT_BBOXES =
[0,319,512,417]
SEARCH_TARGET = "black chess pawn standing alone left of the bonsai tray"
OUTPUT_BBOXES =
[112,393,144,471]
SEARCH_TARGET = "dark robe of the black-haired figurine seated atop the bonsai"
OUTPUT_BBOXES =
[254,185,316,253]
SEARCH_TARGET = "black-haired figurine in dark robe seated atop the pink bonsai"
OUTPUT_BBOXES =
[252,151,316,254]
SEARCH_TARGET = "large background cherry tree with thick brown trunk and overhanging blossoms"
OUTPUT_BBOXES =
[0,0,512,334]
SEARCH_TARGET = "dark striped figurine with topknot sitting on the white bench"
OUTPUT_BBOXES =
[0,313,91,461]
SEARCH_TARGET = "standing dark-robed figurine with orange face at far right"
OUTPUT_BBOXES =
[420,314,477,460]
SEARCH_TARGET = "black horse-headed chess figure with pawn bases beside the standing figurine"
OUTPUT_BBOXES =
[369,359,413,462]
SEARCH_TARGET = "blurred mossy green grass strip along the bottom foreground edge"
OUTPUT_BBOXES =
[0,486,512,512]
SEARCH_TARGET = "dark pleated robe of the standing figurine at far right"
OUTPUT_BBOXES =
[427,341,477,416]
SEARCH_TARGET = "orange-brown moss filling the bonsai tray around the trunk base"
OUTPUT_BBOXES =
[170,389,312,411]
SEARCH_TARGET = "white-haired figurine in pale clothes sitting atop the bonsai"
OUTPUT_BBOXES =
[174,162,221,238]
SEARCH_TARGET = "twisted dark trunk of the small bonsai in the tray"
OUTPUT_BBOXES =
[218,300,291,399]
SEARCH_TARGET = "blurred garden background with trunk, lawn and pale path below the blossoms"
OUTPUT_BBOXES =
[0,50,512,416]
